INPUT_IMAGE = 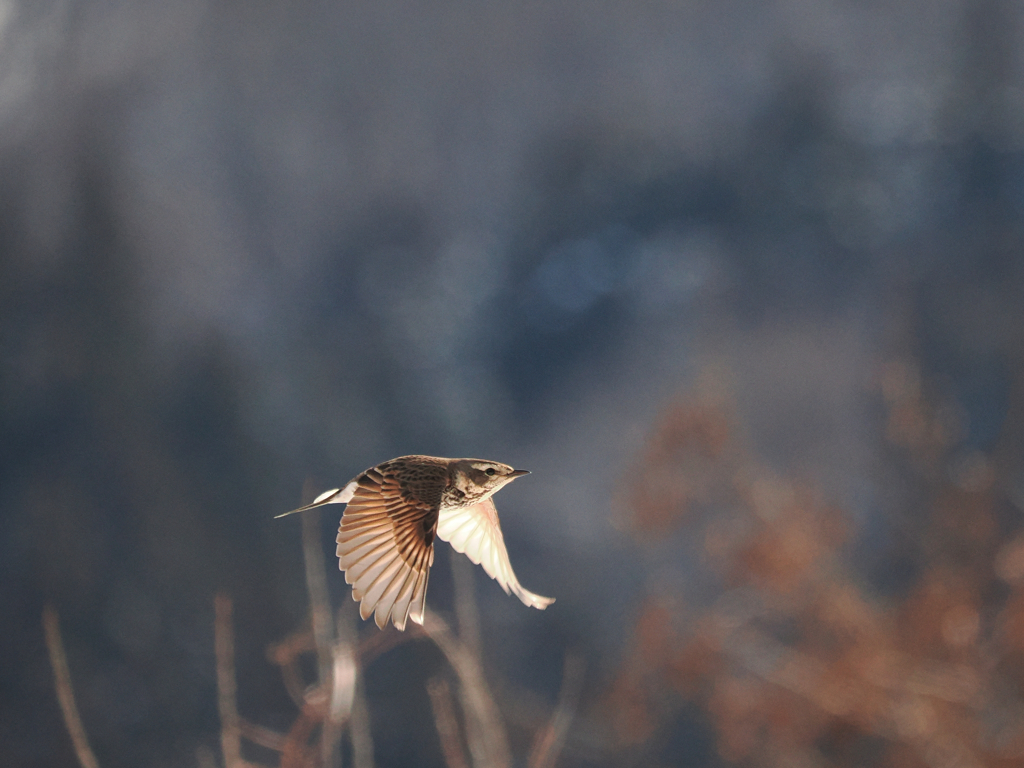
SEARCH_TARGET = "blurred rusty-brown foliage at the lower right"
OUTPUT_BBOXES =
[604,361,1024,766]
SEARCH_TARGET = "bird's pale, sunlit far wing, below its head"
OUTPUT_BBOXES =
[437,499,555,610]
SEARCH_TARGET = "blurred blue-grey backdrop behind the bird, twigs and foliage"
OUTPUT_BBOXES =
[0,0,1024,768]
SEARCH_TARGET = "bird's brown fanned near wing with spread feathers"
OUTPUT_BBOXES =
[337,468,437,630]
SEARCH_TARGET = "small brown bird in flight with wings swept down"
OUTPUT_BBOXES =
[276,456,555,631]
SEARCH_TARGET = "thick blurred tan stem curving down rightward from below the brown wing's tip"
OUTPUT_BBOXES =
[423,610,511,768]
